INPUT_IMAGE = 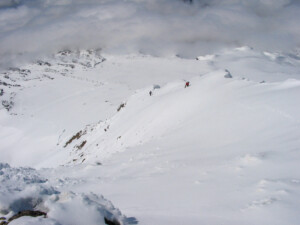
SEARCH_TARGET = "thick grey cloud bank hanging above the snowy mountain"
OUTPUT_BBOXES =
[0,0,300,66]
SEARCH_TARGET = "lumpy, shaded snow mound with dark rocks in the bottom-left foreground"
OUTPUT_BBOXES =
[0,163,127,225]
